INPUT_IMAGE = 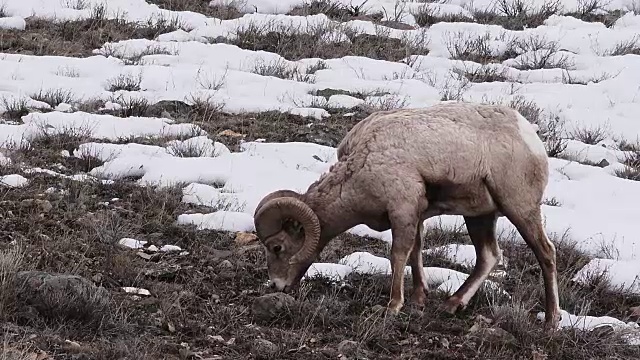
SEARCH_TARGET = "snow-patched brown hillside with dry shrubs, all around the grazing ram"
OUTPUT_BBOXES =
[0,0,640,360]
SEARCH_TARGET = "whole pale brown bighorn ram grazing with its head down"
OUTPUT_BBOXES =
[254,103,560,328]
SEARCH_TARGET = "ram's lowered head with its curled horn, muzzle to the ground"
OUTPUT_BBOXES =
[254,190,320,292]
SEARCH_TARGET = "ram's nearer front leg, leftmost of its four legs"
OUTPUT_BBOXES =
[387,207,418,314]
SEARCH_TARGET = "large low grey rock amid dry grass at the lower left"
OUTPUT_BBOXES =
[16,271,111,323]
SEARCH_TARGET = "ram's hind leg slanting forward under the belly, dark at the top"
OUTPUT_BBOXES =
[443,213,499,314]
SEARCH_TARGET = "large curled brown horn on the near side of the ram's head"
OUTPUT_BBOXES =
[254,196,320,264]
